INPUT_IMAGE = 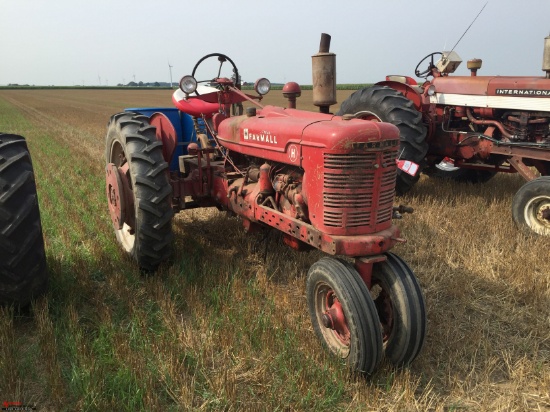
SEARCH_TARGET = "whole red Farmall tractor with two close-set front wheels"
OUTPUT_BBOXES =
[106,36,426,374]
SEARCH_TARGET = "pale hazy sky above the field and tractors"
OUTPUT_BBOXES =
[0,0,550,86]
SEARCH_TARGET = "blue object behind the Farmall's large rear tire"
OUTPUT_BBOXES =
[124,107,204,171]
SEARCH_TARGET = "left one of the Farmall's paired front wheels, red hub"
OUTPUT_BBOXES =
[306,257,382,374]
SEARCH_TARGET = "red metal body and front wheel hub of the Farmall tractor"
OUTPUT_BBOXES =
[171,47,412,302]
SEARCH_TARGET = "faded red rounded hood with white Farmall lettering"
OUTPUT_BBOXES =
[217,106,399,166]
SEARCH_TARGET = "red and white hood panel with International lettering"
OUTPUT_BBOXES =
[430,76,550,111]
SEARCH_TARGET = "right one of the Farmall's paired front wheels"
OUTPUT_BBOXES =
[371,253,426,366]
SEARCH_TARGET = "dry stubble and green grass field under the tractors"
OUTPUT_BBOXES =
[0,89,550,411]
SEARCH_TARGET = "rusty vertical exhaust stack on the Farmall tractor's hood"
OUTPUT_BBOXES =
[311,33,336,113]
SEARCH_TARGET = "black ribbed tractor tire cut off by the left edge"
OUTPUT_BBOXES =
[0,134,48,307]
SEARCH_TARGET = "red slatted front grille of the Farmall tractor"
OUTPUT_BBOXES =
[323,150,397,228]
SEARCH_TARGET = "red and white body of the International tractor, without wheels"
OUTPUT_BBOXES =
[377,47,550,180]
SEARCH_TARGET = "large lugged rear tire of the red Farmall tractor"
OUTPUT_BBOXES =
[105,113,174,272]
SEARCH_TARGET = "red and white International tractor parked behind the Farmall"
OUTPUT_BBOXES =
[337,36,550,236]
